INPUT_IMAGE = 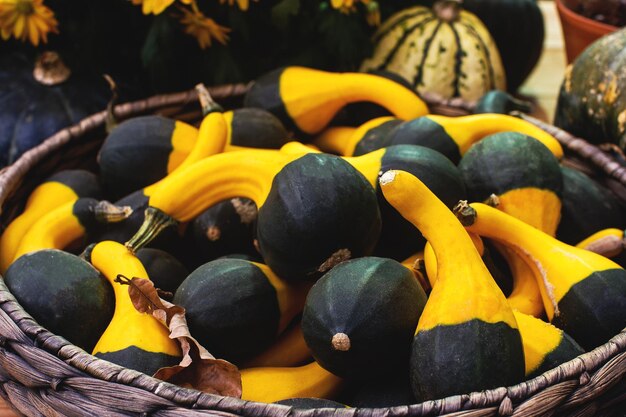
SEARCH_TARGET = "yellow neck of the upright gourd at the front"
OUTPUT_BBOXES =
[380,171,517,332]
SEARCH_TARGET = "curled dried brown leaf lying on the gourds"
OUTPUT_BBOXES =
[117,275,241,398]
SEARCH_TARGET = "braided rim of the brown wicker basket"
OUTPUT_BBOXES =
[0,84,626,416]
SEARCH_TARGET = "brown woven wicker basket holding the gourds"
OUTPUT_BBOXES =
[0,85,626,417]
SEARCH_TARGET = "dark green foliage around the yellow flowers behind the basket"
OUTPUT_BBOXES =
[3,0,414,94]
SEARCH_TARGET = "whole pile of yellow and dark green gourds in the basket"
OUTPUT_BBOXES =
[0,67,626,407]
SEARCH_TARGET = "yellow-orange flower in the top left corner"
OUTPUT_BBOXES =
[0,0,59,46]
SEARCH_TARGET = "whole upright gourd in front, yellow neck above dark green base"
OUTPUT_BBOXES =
[380,171,524,401]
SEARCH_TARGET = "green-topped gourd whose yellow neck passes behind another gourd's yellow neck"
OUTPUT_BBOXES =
[459,132,563,317]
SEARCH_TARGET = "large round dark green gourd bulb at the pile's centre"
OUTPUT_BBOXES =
[257,154,381,279]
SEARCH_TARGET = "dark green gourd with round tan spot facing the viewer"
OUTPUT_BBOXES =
[302,257,426,377]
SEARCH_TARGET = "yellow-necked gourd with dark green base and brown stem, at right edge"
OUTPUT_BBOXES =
[455,203,626,350]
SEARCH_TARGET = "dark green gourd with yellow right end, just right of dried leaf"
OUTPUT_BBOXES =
[173,259,311,363]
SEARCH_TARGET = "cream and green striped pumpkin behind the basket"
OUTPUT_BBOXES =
[361,0,506,101]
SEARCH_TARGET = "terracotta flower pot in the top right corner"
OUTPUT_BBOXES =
[556,0,619,63]
